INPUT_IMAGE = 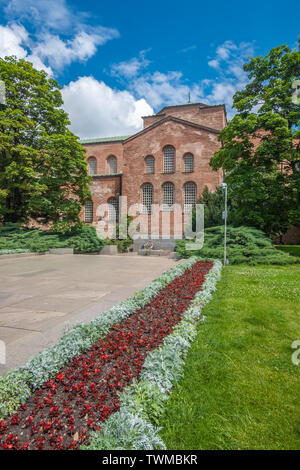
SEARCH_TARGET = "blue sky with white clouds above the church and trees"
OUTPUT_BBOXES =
[0,0,300,138]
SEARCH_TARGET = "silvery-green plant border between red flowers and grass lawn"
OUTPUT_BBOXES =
[81,260,222,450]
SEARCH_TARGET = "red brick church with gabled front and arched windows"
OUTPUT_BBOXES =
[81,103,226,237]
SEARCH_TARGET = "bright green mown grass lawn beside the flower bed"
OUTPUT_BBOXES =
[160,265,300,450]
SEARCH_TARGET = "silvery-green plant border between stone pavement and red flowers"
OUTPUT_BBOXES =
[0,257,204,419]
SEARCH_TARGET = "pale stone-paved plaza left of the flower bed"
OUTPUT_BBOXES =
[0,255,175,375]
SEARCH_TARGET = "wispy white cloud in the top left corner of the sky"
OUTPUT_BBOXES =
[0,0,119,71]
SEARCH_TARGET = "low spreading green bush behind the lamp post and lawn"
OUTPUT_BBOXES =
[177,226,299,265]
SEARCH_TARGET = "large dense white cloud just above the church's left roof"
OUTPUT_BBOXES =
[62,77,153,138]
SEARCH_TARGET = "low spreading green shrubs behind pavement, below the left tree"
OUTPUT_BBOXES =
[0,224,105,254]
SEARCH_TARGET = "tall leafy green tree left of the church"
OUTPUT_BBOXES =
[0,57,90,230]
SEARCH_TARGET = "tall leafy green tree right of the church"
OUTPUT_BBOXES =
[210,45,300,235]
